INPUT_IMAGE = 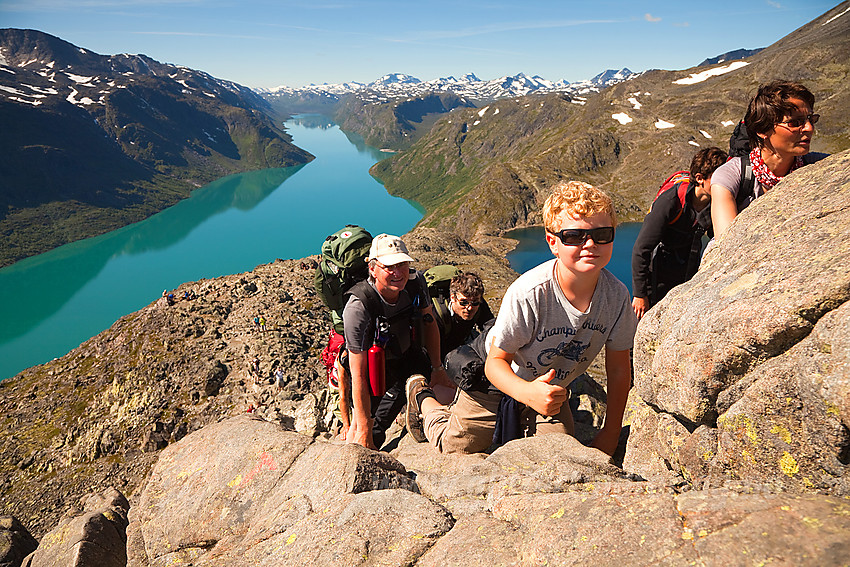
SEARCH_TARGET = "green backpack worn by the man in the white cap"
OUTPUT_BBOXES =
[313,224,372,334]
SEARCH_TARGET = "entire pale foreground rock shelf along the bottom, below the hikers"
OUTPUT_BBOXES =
[128,416,850,567]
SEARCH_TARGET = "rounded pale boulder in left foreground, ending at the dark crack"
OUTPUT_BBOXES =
[129,417,453,566]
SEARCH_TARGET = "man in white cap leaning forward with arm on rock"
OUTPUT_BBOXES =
[342,234,450,448]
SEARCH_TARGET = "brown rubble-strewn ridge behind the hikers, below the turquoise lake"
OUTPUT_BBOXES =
[0,229,516,537]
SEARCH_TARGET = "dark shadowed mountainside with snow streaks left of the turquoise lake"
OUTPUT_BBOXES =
[0,29,312,266]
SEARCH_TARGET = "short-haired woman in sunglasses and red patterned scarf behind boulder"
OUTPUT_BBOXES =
[711,81,826,238]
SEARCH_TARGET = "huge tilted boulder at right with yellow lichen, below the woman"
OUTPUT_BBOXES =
[624,152,850,495]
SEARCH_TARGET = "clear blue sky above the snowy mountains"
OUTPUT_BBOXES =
[0,0,838,87]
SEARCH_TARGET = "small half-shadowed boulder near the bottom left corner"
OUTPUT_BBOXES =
[22,488,130,567]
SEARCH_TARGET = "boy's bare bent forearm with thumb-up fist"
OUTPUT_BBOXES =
[484,346,567,415]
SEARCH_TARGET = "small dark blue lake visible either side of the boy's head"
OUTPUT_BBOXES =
[505,222,643,293]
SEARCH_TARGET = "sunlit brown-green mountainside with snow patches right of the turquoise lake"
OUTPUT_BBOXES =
[373,2,850,242]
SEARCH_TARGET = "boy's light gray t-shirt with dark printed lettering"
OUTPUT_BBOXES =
[488,259,637,386]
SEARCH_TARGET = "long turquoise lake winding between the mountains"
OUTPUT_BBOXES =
[0,115,422,379]
